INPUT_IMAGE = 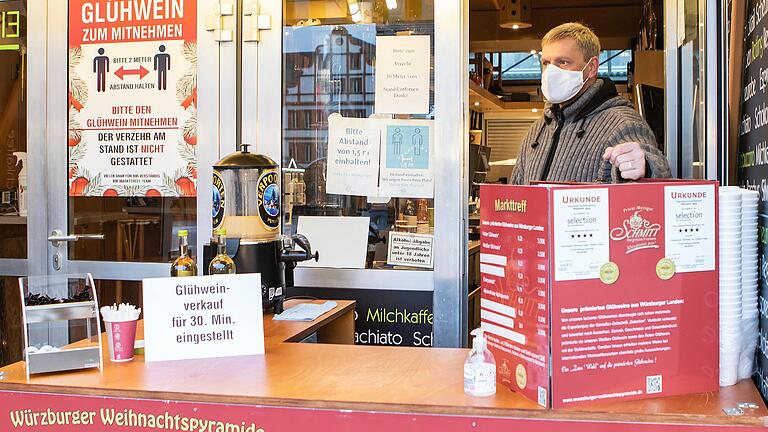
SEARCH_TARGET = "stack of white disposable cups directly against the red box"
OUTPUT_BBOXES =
[719,188,742,386]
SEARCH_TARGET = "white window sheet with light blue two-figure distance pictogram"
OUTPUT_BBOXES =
[379,120,435,198]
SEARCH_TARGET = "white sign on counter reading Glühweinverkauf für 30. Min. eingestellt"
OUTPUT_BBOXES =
[143,274,264,362]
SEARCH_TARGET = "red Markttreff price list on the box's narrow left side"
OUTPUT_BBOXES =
[480,186,549,406]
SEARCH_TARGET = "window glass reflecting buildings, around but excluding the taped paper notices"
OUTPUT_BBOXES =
[282,0,434,268]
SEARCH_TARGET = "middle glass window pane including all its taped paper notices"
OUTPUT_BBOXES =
[282,0,435,269]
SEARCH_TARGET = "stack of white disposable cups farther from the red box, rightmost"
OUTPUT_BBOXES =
[739,189,759,379]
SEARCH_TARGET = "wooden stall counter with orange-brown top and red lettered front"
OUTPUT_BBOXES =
[0,300,768,432]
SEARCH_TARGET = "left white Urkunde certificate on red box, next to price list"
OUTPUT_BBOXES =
[553,188,610,281]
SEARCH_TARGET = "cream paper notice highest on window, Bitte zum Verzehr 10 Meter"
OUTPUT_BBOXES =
[375,36,431,114]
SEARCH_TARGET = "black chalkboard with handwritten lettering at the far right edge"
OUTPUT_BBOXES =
[738,0,768,398]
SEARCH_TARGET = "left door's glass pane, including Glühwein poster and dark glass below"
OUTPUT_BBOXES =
[61,0,198,262]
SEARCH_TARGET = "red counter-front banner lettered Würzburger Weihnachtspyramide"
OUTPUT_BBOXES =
[0,392,763,432]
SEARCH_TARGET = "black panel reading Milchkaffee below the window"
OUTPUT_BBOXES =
[288,288,433,346]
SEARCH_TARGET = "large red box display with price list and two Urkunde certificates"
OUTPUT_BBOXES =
[480,181,719,407]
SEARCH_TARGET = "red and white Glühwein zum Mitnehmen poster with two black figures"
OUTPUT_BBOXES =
[68,0,197,197]
